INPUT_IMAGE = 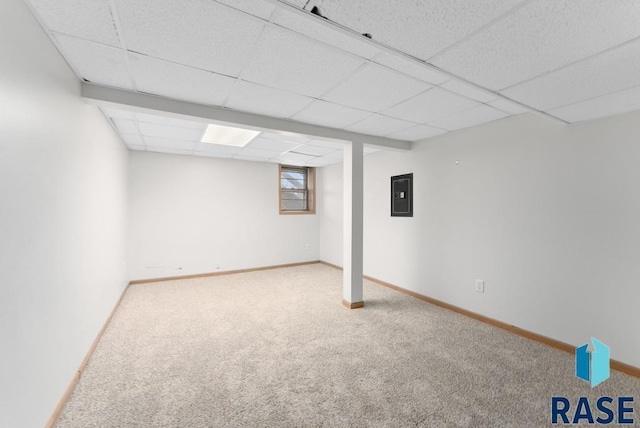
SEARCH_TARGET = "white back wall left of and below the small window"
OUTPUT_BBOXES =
[129,152,319,279]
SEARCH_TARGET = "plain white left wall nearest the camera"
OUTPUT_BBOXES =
[0,0,127,427]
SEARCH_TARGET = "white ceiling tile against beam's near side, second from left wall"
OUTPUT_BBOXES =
[129,54,235,106]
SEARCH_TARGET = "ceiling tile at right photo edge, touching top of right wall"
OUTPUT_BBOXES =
[549,86,640,122]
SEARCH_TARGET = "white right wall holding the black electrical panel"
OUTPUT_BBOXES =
[320,112,640,366]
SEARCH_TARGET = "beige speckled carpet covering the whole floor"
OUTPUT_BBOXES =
[57,265,640,428]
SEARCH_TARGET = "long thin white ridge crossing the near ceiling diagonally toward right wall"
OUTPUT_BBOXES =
[266,0,569,125]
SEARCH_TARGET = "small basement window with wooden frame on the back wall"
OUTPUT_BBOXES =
[279,165,316,214]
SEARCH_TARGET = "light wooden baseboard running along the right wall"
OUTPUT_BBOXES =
[320,260,640,378]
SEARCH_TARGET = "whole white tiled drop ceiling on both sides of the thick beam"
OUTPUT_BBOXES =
[26,0,640,166]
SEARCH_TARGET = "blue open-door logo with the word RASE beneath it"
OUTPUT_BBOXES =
[551,337,634,425]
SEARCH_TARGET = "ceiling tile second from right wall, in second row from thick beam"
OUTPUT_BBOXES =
[383,88,478,124]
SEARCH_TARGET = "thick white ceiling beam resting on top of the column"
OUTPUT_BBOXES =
[82,82,411,150]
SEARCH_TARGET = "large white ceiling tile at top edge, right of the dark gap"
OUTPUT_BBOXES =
[318,0,522,59]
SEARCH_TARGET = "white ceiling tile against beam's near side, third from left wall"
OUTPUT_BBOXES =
[226,81,313,119]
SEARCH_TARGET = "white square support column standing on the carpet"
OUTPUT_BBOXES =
[342,142,364,309]
